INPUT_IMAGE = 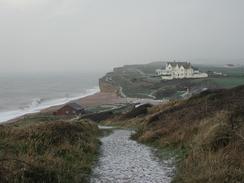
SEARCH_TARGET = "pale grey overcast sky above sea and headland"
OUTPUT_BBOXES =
[0,0,244,72]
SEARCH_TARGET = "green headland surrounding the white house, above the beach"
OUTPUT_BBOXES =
[102,62,244,99]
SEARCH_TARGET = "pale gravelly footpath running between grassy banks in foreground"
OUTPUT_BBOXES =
[91,130,173,183]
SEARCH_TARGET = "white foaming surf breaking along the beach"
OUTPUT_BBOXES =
[0,87,99,123]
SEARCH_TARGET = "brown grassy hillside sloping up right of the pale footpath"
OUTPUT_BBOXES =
[106,86,244,183]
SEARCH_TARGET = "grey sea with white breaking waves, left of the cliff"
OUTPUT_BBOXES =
[0,72,104,123]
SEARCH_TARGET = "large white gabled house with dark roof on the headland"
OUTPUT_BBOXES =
[156,62,208,80]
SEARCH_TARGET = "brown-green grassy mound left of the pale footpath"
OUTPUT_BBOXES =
[0,115,100,183]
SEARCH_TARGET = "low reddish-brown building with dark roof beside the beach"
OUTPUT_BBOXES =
[54,103,85,116]
